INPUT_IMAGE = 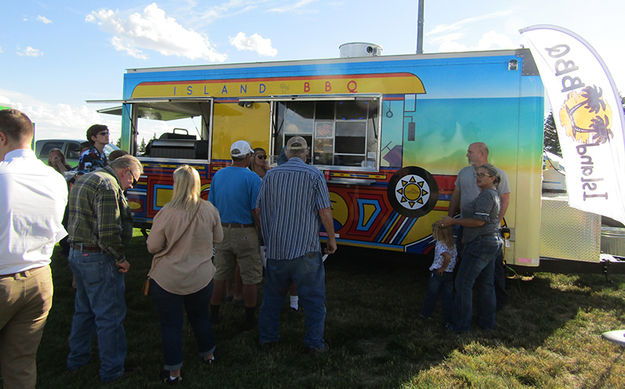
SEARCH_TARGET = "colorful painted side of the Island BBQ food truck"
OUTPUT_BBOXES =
[122,51,543,262]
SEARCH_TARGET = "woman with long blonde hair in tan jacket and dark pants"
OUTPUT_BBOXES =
[147,165,223,383]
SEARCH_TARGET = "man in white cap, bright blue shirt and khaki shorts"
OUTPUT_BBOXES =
[208,140,263,330]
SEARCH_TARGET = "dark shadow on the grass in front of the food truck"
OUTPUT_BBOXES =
[38,236,625,388]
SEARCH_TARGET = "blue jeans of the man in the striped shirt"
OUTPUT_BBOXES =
[258,252,326,348]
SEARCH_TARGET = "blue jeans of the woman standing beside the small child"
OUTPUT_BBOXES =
[454,234,502,332]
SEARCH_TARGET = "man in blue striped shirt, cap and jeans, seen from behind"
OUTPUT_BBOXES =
[256,136,336,352]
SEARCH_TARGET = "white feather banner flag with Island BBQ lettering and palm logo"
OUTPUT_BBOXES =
[520,25,625,223]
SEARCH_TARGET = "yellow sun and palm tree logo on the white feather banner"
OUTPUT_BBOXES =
[560,85,614,144]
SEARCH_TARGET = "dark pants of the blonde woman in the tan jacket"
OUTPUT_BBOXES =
[150,280,215,371]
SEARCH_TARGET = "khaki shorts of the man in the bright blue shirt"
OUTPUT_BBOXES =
[215,227,263,285]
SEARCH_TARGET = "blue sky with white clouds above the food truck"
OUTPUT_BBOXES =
[0,0,625,142]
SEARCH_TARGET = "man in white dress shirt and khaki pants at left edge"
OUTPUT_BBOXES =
[0,109,67,389]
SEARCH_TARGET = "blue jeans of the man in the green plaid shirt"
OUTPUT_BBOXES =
[67,249,126,382]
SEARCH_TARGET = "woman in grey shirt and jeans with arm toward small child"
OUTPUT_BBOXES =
[442,164,502,332]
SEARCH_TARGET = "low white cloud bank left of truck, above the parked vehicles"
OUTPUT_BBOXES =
[0,89,121,142]
